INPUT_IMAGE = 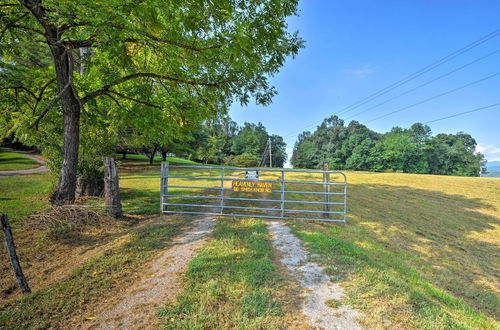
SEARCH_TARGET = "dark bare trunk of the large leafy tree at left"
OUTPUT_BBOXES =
[51,46,80,204]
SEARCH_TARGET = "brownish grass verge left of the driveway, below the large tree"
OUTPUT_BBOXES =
[0,210,190,329]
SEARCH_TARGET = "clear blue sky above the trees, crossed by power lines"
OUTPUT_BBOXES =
[230,0,500,165]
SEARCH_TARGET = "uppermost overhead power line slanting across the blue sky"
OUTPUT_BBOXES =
[284,29,500,137]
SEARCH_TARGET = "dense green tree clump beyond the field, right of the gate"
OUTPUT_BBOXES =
[291,116,486,176]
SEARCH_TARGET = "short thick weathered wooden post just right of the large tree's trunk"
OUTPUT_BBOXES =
[104,157,123,218]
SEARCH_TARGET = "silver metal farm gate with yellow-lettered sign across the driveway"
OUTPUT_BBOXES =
[160,162,347,223]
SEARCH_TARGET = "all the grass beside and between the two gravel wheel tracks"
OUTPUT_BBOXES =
[0,158,500,329]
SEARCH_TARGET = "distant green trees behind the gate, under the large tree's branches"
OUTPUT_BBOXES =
[118,115,287,167]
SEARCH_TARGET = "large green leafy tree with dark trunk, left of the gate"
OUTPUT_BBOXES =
[0,0,302,202]
